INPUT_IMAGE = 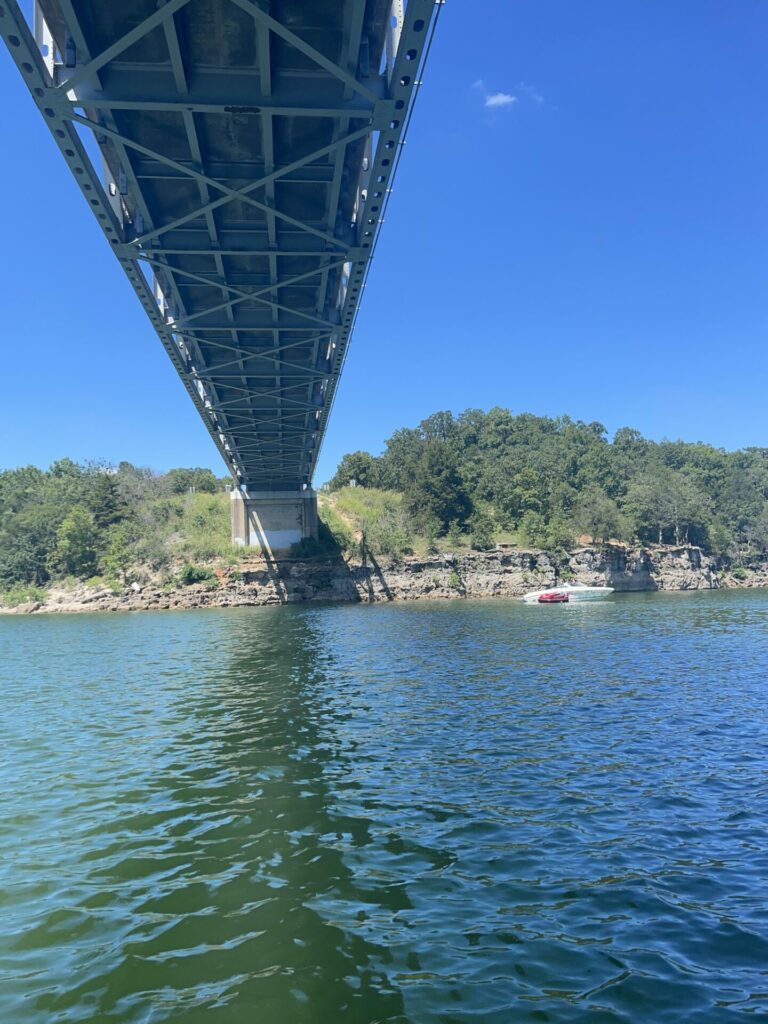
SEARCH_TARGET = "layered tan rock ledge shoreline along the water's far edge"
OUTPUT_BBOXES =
[0,545,768,614]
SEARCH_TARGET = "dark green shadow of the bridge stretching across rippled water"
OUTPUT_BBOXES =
[13,609,410,1024]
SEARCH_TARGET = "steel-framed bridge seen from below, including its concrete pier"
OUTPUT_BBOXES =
[0,0,443,551]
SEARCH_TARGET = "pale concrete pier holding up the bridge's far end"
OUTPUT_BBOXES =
[231,489,317,555]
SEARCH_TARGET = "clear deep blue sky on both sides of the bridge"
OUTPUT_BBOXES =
[0,0,768,482]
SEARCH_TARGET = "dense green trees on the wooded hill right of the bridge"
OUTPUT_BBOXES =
[329,408,768,564]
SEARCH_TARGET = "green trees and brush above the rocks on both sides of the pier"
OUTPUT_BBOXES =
[0,409,768,593]
